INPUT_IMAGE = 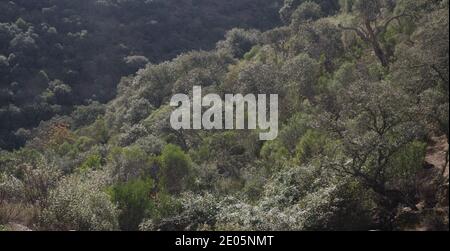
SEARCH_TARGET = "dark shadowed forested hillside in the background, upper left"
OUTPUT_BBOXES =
[0,0,280,149]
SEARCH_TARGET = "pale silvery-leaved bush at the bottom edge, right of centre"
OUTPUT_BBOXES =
[215,166,370,231]
